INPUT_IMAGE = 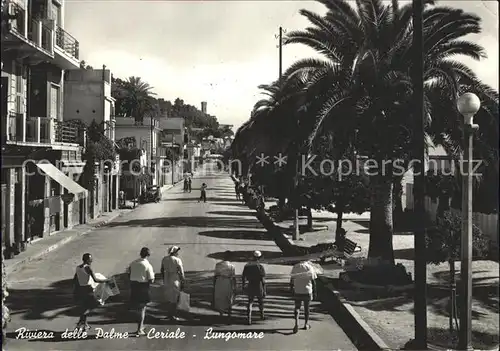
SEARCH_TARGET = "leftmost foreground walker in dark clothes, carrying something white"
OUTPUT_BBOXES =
[73,253,108,330]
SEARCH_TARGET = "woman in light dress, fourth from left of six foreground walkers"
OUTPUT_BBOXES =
[213,251,236,318]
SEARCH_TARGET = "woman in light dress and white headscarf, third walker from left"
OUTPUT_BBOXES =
[161,246,185,320]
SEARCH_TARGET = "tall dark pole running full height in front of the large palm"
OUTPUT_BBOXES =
[412,0,427,350]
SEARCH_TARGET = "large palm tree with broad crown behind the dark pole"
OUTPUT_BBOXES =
[285,0,496,262]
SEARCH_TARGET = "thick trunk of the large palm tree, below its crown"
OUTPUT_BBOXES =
[368,174,394,264]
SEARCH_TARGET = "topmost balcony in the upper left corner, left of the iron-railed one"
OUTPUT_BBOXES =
[2,2,54,64]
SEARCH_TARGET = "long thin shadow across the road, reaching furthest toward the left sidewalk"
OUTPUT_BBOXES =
[104,217,262,229]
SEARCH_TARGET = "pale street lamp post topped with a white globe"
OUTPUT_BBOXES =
[457,93,481,351]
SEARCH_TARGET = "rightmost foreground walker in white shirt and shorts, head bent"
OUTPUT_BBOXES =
[290,261,318,333]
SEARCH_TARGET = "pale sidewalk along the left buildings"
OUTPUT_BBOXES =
[4,209,132,275]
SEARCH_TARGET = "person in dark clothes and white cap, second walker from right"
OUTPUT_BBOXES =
[241,251,266,325]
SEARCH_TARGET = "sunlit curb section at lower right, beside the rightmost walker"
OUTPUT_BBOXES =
[318,276,391,350]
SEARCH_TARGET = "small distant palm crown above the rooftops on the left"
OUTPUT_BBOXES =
[112,76,158,123]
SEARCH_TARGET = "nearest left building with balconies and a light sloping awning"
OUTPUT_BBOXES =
[1,0,88,257]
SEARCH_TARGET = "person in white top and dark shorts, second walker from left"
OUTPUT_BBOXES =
[127,247,155,336]
